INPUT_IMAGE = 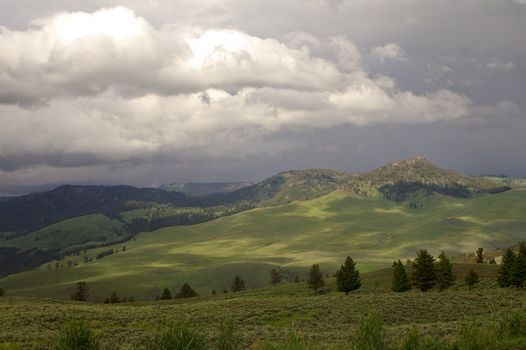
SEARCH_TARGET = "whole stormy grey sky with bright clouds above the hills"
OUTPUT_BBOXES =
[0,0,526,195]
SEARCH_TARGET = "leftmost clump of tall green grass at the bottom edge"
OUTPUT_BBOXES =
[56,321,100,350]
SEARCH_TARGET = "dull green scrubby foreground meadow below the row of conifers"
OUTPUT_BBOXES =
[0,283,526,349]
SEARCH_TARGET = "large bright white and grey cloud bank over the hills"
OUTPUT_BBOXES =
[0,7,518,178]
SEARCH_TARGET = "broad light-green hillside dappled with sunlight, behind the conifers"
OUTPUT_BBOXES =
[0,190,526,299]
